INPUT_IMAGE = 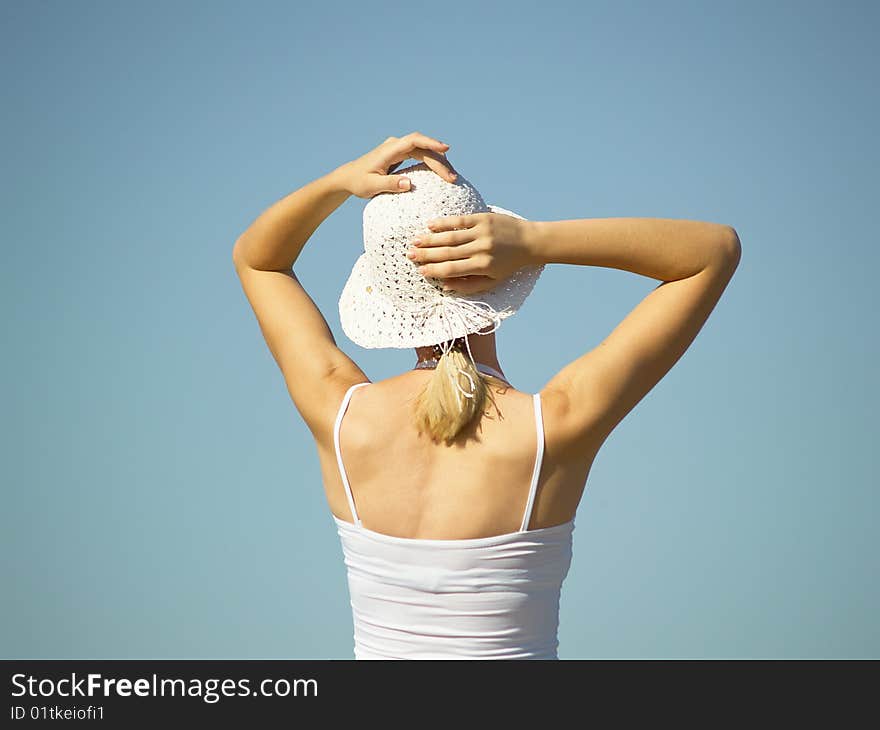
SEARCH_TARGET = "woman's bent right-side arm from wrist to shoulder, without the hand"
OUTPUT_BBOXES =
[531,218,742,454]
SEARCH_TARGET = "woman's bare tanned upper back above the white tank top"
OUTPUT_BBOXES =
[320,371,595,539]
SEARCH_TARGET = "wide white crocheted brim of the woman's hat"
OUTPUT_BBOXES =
[339,205,544,349]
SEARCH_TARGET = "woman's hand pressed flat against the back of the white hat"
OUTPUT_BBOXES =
[407,213,536,294]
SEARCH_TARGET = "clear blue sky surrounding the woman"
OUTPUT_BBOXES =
[0,1,880,659]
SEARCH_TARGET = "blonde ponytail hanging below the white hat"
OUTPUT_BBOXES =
[413,340,509,446]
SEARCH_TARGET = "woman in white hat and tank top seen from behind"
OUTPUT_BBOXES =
[233,132,740,659]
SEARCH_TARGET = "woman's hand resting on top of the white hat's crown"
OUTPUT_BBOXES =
[335,132,457,198]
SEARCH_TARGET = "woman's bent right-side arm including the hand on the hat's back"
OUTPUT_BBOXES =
[410,213,741,455]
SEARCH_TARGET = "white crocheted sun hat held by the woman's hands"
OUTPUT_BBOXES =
[339,163,544,348]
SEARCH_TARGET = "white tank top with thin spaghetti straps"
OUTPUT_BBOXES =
[333,382,574,659]
